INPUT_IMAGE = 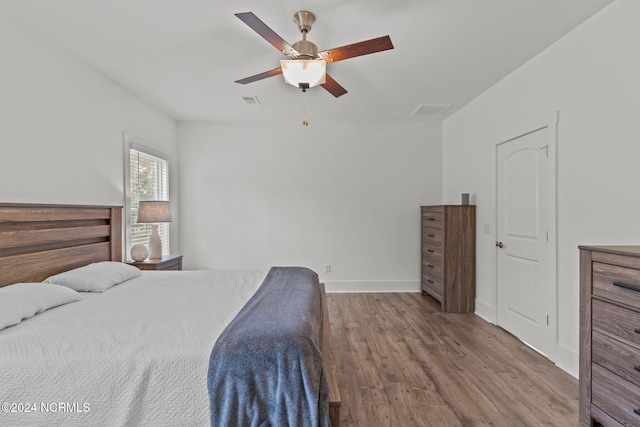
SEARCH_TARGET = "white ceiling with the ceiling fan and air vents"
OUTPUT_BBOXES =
[0,0,612,122]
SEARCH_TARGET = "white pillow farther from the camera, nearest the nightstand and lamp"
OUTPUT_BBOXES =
[44,261,142,292]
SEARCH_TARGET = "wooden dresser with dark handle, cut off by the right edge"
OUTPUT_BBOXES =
[579,246,640,427]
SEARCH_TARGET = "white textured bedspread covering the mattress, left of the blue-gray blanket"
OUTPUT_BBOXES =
[0,271,266,426]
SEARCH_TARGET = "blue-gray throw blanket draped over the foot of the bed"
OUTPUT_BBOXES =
[207,267,330,427]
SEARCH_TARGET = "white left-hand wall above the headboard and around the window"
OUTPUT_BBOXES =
[0,9,178,254]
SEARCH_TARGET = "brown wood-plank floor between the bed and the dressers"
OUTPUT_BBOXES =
[327,293,578,427]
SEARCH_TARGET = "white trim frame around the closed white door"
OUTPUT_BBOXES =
[493,111,559,362]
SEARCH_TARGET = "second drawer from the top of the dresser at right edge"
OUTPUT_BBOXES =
[592,298,640,351]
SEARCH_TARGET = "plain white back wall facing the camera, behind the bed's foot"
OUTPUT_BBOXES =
[179,122,442,291]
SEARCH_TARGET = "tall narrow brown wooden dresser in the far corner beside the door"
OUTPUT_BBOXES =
[420,205,476,313]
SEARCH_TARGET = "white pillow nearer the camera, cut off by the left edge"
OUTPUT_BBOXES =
[0,283,81,330]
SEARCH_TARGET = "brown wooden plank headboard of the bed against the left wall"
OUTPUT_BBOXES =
[0,203,122,287]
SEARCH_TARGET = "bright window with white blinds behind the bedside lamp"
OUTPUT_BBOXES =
[125,134,169,257]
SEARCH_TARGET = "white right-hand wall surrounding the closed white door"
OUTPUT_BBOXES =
[443,0,640,375]
